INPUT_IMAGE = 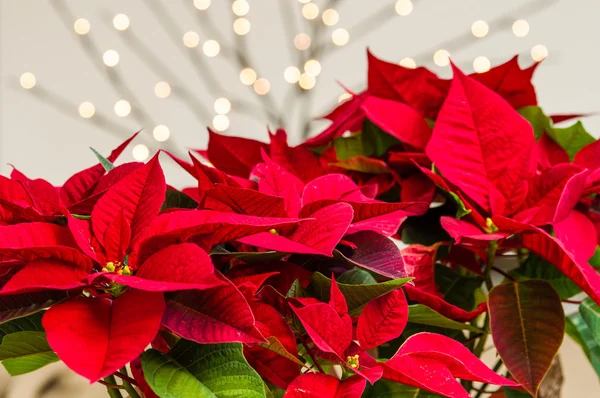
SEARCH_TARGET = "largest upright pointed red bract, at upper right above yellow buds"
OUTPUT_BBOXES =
[426,67,535,215]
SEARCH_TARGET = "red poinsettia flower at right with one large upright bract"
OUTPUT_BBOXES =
[426,63,600,301]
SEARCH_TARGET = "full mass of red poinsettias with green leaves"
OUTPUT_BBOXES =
[0,49,600,398]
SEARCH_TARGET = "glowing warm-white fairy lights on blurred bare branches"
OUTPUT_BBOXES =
[20,0,548,161]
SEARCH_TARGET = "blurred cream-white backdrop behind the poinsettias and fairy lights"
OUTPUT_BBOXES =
[0,0,600,398]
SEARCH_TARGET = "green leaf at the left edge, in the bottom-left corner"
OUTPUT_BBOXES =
[0,331,58,376]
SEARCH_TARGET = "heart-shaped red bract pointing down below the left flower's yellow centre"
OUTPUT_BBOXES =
[42,290,165,383]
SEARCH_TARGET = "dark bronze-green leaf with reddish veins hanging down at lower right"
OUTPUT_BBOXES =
[488,279,565,396]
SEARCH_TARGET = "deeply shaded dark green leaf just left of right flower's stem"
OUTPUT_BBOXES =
[435,264,483,311]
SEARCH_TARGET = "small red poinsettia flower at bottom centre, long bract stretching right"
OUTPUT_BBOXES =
[288,279,518,397]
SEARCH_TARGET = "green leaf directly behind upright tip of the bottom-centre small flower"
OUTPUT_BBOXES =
[310,272,412,315]
